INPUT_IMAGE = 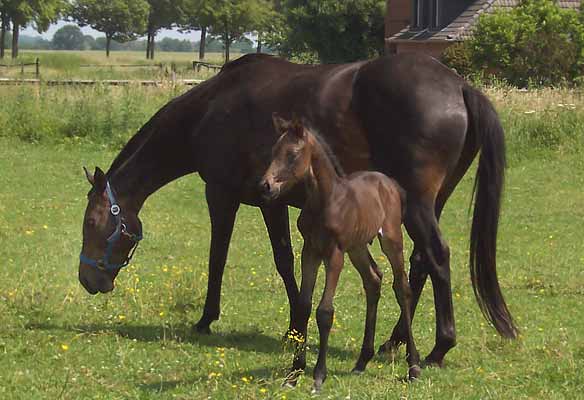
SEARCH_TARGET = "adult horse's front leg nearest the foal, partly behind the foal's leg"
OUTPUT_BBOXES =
[261,205,298,331]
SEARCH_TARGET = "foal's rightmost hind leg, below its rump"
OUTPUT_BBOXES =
[379,221,420,379]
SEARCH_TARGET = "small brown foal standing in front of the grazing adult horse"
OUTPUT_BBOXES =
[260,114,420,391]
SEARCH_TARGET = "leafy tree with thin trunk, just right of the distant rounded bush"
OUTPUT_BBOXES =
[71,0,150,57]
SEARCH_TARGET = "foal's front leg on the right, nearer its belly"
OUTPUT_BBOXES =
[313,246,343,392]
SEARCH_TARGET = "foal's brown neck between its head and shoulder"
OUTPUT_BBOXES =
[308,135,343,209]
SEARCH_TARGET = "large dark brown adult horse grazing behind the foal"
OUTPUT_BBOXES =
[79,54,516,365]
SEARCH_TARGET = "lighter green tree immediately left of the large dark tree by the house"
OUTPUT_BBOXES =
[209,0,273,62]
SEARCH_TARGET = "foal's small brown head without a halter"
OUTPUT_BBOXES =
[260,113,311,200]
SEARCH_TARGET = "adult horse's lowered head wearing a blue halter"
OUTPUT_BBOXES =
[79,168,142,294]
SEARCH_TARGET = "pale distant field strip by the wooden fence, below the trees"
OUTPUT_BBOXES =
[0,50,233,80]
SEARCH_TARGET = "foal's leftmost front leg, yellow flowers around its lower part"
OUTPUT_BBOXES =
[284,242,322,386]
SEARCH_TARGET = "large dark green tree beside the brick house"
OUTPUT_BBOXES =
[266,0,386,63]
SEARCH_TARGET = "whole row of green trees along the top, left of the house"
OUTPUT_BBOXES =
[0,0,386,62]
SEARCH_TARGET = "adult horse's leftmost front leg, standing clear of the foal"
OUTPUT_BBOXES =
[194,184,239,333]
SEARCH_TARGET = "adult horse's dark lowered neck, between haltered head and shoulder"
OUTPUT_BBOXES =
[107,101,200,213]
